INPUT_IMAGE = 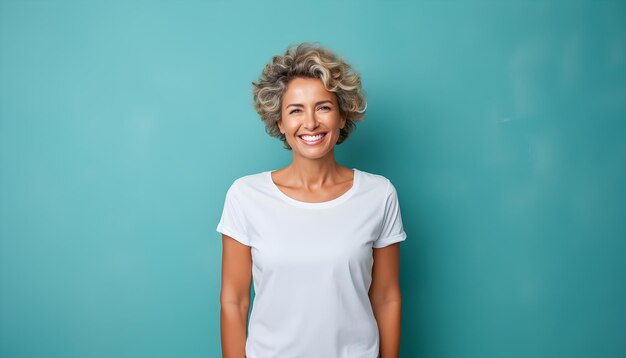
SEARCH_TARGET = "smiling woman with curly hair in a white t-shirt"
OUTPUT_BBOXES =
[217,43,407,358]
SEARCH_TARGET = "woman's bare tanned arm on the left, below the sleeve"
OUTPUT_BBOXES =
[220,234,252,358]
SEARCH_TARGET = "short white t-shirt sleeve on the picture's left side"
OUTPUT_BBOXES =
[216,182,250,246]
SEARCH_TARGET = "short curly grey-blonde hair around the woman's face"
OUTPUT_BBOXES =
[252,42,367,150]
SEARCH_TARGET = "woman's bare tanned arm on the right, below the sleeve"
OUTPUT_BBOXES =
[369,243,402,358]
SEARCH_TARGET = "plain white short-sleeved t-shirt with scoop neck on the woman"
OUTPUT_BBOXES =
[217,168,407,358]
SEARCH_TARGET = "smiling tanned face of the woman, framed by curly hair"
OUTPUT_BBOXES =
[277,78,346,159]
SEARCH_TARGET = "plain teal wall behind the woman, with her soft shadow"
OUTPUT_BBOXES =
[0,0,626,357]
